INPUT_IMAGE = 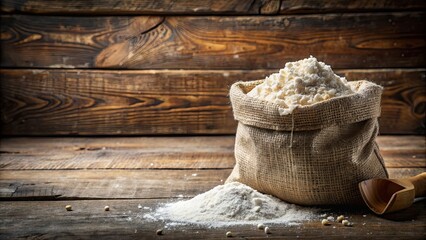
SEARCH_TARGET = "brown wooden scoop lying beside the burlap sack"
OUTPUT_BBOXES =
[358,172,426,214]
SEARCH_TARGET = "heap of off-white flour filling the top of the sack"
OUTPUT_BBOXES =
[247,56,353,115]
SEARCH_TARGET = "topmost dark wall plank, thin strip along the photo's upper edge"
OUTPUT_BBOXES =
[0,0,426,15]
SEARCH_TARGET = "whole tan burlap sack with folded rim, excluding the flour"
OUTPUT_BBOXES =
[227,80,388,205]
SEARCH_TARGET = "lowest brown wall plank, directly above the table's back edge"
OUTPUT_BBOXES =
[0,69,426,135]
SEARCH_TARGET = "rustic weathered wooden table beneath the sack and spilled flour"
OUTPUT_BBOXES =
[0,136,426,239]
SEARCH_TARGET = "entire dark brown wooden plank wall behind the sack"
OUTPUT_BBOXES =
[0,0,426,135]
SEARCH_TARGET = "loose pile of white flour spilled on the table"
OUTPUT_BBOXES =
[143,182,316,228]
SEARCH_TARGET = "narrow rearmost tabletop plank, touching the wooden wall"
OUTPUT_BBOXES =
[0,135,426,152]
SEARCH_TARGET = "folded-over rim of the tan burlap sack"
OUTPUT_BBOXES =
[230,80,383,131]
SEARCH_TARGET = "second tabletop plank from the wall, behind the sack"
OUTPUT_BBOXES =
[0,148,426,170]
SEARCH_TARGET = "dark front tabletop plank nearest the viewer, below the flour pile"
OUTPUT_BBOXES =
[0,199,426,240]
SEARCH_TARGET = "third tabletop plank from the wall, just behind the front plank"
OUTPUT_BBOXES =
[0,168,426,200]
